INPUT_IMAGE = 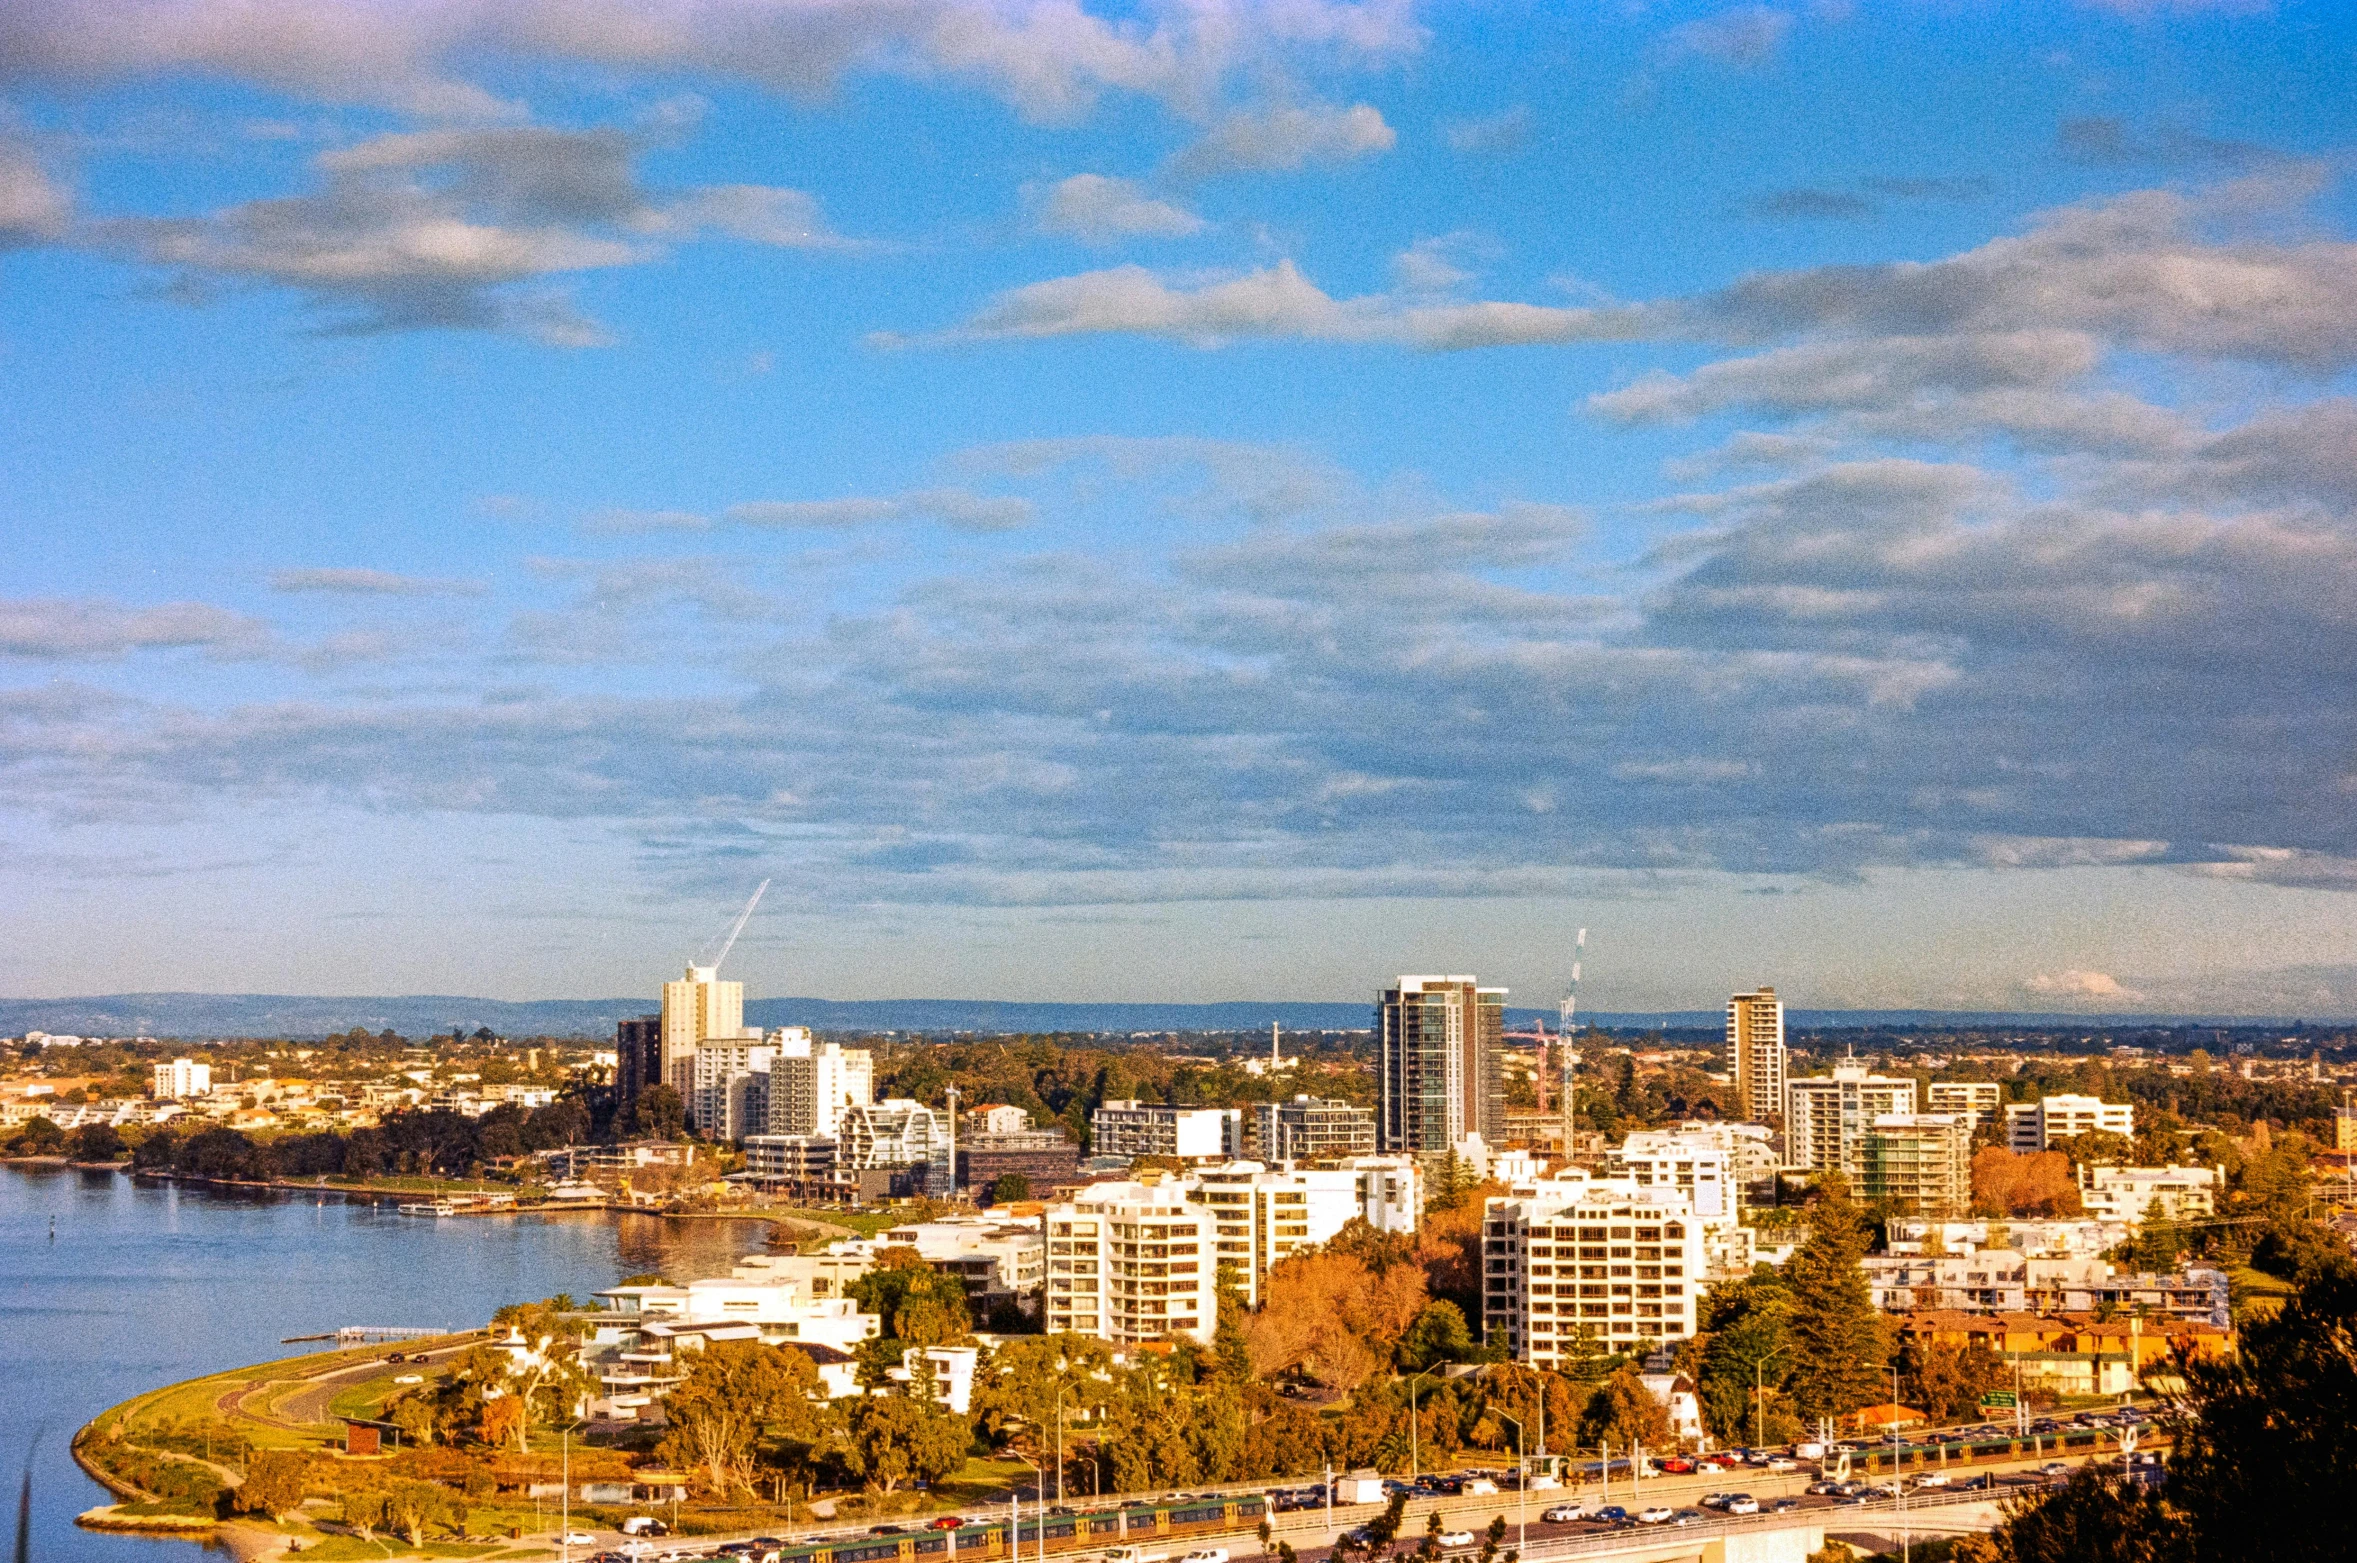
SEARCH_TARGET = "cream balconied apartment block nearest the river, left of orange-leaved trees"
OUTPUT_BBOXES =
[1044,1179,1219,1346]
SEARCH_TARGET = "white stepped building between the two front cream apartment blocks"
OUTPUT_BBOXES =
[1188,1155,1419,1308]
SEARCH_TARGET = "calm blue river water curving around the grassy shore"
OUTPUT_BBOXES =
[0,1167,766,1563]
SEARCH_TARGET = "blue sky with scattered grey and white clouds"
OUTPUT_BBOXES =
[0,0,2357,1016]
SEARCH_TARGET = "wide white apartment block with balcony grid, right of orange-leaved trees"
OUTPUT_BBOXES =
[1483,1179,1704,1367]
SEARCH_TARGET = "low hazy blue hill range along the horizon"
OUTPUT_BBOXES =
[0,992,2309,1040]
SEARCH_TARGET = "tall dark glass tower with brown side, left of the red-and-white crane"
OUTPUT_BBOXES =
[1374,976,1506,1155]
